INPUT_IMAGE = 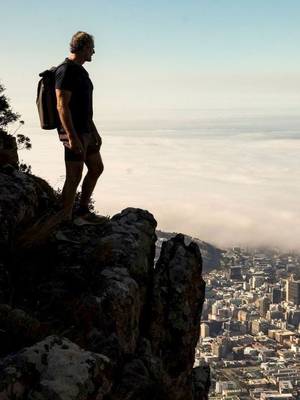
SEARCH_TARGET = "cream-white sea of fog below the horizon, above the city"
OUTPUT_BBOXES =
[20,110,300,250]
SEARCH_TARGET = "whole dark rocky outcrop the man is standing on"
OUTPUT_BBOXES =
[0,168,209,400]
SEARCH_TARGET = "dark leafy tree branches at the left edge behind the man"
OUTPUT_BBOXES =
[0,83,32,172]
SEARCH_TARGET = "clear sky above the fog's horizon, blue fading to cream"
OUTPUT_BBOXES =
[0,0,300,121]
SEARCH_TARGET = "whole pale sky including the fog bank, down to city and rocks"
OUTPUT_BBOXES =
[0,0,300,248]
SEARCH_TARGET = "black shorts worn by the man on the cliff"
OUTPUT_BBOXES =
[58,130,102,161]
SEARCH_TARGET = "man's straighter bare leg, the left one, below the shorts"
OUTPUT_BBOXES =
[62,161,83,219]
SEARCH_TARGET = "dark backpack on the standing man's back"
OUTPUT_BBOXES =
[36,63,64,130]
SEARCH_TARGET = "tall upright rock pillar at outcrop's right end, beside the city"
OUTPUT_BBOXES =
[150,235,205,400]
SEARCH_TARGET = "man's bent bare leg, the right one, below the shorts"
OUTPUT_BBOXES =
[80,152,104,209]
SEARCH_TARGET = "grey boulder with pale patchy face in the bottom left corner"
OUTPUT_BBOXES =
[0,336,112,400]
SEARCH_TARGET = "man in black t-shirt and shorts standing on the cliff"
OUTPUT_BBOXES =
[55,31,103,223]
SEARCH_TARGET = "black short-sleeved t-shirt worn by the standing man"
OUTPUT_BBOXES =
[55,58,93,133]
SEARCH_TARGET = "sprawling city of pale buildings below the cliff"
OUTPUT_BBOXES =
[195,248,300,400]
